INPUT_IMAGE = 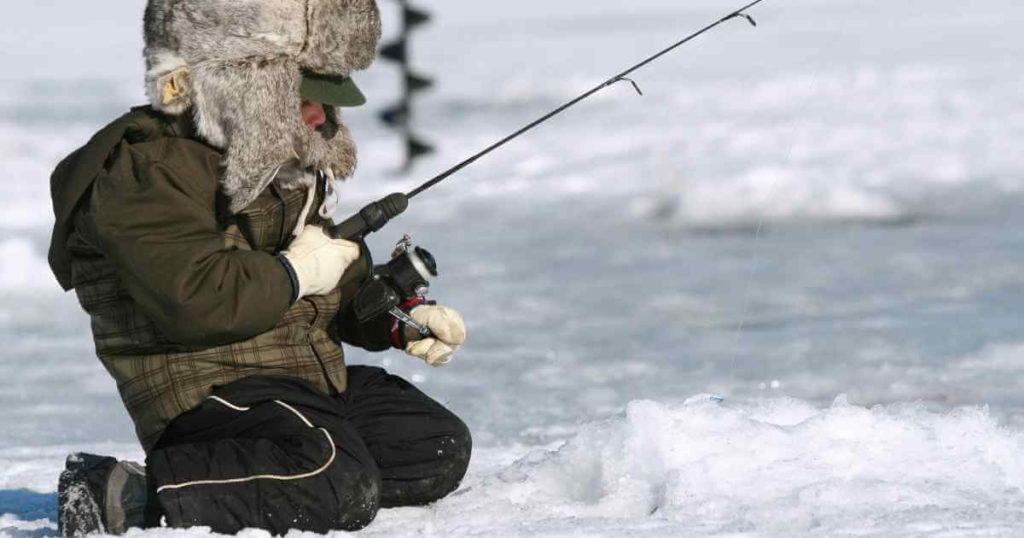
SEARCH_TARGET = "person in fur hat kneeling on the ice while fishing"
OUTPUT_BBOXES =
[44,0,471,536]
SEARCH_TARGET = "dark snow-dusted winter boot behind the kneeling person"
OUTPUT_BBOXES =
[57,452,152,538]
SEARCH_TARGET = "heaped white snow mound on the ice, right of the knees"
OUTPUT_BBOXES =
[371,397,1024,536]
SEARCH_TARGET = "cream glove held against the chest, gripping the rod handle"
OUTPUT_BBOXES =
[281,226,359,298]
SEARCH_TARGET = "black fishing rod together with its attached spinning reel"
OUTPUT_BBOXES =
[328,0,764,338]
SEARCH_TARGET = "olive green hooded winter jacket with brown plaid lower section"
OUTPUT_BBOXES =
[49,108,386,451]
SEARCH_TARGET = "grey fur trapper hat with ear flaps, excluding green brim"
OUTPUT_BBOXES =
[144,0,381,212]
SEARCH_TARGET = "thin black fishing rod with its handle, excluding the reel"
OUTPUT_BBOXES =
[328,0,764,241]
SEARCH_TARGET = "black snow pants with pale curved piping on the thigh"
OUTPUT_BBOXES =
[146,366,472,534]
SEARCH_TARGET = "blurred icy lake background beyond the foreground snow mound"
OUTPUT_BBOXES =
[0,0,1024,491]
